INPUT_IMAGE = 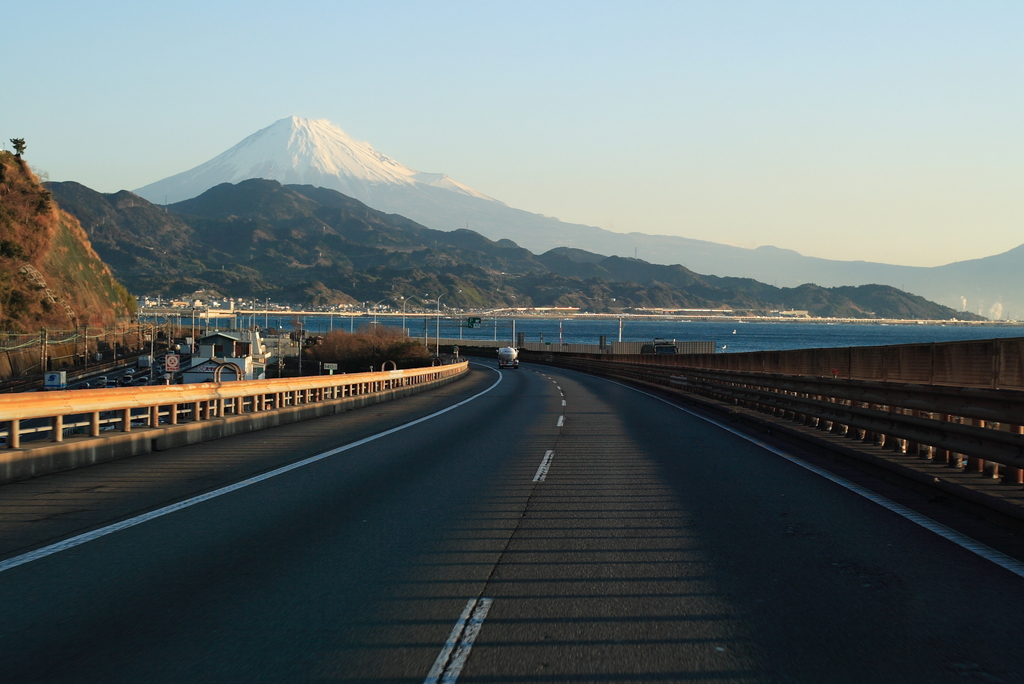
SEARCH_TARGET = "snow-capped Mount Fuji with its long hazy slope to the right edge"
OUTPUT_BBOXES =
[135,117,1024,318]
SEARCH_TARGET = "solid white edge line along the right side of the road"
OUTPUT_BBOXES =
[584,374,1024,578]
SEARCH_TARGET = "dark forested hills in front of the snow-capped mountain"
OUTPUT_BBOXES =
[50,179,973,318]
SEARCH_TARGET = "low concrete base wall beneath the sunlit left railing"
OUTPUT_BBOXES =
[0,374,466,484]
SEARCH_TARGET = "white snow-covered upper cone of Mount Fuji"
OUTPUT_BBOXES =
[135,117,490,204]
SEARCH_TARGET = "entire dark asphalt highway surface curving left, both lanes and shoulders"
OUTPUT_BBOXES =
[0,362,1024,684]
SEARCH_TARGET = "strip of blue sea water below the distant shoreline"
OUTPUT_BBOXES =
[182,315,1024,353]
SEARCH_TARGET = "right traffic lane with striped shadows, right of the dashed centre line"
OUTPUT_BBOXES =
[464,370,1024,682]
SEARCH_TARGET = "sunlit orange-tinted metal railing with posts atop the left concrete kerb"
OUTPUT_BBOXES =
[0,361,468,448]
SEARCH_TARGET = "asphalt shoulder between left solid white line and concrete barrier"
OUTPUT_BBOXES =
[0,371,495,558]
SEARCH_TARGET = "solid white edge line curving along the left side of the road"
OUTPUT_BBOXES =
[0,367,502,572]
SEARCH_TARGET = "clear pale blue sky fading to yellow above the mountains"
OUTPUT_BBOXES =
[6,0,1024,265]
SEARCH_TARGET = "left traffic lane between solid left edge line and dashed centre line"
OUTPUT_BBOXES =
[0,371,557,682]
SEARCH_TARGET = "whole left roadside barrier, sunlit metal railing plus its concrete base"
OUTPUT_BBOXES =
[0,361,468,483]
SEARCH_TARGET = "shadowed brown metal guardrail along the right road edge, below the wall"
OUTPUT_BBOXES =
[527,354,1024,484]
